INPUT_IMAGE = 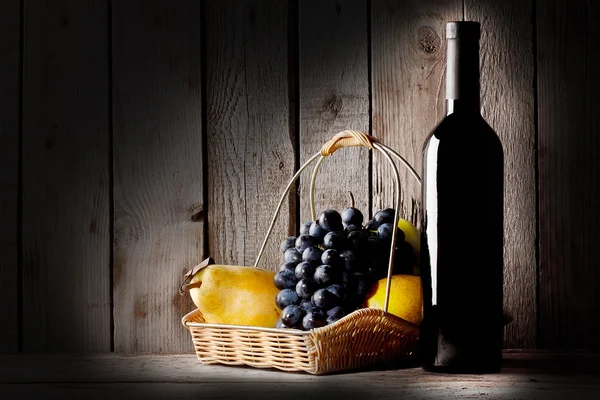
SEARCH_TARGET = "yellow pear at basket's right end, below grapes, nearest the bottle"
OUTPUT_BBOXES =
[366,275,423,325]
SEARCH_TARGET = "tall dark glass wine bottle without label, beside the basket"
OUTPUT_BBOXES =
[420,21,504,373]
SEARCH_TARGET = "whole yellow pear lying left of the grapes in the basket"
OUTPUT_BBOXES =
[187,264,281,328]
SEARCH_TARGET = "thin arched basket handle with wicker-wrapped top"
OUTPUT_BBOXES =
[254,130,421,312]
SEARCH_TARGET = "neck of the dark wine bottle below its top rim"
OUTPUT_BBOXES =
[446,38,480,115]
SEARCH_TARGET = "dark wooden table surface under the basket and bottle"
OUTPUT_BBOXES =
[0,351,600,400]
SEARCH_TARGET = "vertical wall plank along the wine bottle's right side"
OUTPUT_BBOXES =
[465,0,537,348]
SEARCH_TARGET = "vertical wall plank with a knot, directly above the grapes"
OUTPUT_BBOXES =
[299,0,369,222]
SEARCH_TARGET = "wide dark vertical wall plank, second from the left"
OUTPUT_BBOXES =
[22,0,110,352]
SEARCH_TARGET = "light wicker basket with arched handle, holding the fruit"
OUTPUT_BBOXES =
[182,131,419,374]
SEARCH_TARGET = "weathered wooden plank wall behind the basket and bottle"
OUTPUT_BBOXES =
[0,0,600,352]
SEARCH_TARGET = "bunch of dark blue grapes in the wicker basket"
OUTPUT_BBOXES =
[274,207,414,330]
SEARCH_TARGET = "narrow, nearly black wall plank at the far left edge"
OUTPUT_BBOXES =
[0,0,21,353]
